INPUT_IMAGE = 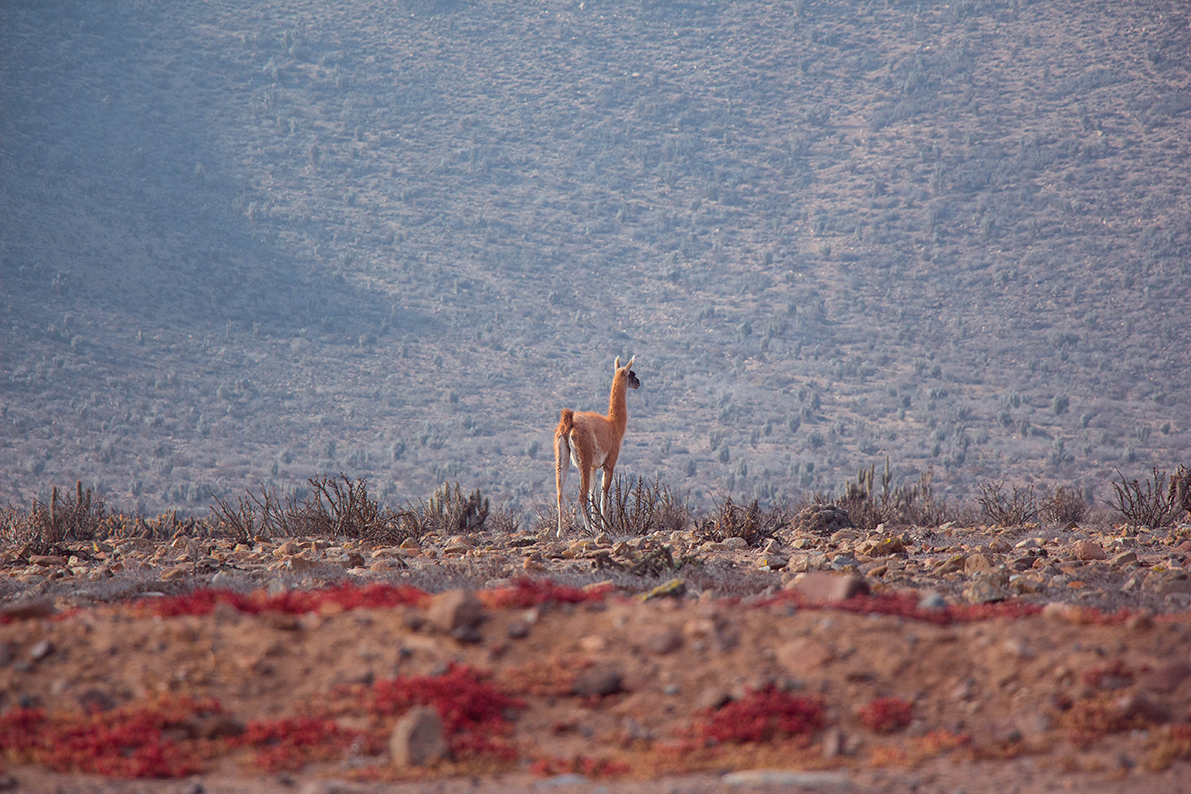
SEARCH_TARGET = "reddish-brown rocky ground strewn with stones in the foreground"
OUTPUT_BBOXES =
[0,525,1191,793]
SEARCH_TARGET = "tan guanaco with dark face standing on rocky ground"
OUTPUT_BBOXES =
[554,356,641,538]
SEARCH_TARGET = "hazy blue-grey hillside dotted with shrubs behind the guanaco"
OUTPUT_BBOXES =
[0,0,1191,514]
